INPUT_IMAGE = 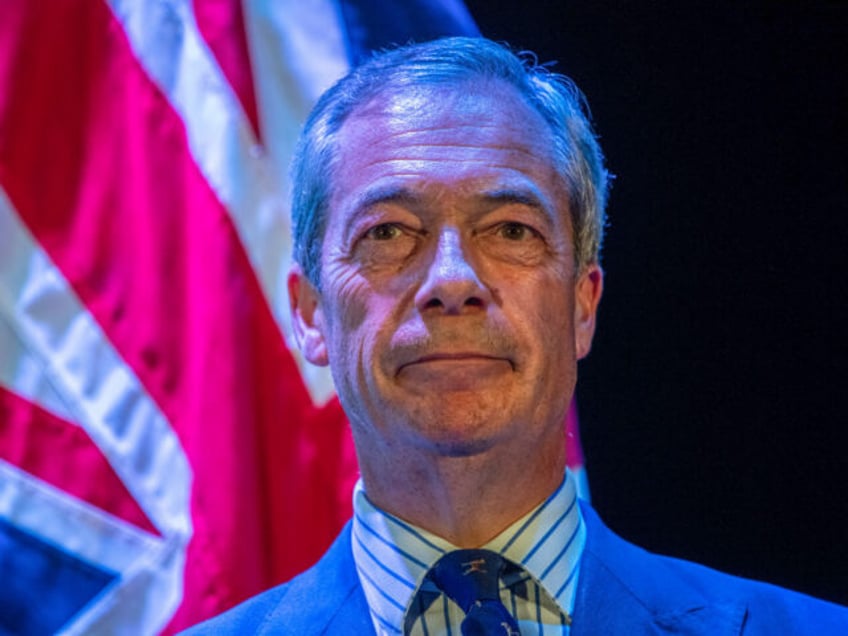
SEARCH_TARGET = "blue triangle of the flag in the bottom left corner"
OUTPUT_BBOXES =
[0,519,117,636]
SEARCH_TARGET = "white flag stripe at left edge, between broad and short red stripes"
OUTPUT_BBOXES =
[0,188,191,542]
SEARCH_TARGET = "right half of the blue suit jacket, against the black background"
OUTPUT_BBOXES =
[575,505,848,635]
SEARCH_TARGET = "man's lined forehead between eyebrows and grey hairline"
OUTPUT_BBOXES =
[331,80,561,207]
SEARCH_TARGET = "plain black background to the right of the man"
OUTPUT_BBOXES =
[467,0,848,604]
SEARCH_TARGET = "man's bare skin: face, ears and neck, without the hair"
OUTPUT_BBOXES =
[289,82,603,547]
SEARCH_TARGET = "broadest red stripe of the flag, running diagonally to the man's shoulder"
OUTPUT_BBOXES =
[0,0,352,628]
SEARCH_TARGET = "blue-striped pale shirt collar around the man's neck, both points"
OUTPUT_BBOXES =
[351,470,586,633]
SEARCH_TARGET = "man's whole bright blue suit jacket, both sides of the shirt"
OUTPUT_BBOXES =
[184,502,848,636]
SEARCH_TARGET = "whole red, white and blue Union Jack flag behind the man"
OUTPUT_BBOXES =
[0,0,582,634]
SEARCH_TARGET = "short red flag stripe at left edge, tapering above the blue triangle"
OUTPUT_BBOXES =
[0,386,159,535]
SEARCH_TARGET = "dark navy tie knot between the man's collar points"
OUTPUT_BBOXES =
[430,550,504,612]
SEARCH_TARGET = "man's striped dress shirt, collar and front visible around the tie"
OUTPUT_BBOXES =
[352,471,586,636]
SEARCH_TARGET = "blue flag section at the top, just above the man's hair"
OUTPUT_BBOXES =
[339,0,480,65]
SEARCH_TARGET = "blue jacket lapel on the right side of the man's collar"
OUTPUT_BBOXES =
[571,502,745,636]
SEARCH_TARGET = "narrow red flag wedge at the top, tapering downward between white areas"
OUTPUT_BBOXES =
[194,0,261,139]
